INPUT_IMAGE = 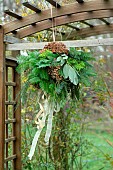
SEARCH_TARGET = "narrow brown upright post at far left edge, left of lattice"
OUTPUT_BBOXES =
[0,28,5,170]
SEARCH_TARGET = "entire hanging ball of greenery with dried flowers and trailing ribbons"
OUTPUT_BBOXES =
[17,42,95,159]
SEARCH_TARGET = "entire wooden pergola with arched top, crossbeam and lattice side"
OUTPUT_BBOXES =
[0,0,113,170]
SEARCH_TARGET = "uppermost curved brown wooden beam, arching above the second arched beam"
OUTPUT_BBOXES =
[4,0,113,34]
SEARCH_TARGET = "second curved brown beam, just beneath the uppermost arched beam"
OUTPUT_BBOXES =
[17,10,113,38]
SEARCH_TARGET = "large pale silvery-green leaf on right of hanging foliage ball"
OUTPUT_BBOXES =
[63,64,78,85]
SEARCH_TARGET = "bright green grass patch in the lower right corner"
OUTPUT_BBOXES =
[83,130,113,170]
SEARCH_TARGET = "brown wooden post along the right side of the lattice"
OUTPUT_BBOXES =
[12,51,22,170]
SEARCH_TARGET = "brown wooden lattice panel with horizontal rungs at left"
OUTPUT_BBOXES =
[4,59,21,170]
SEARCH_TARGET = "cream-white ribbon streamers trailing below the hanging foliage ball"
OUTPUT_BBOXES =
[28,99,60,160]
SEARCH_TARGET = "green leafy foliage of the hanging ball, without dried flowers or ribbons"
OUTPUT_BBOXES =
[17,48,95,103]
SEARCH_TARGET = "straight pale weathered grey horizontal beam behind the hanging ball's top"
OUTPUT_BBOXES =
[6,38,113,51]
